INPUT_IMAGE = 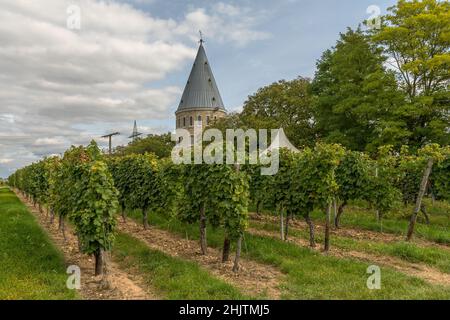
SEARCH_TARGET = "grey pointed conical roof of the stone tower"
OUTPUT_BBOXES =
[177,40,225,111]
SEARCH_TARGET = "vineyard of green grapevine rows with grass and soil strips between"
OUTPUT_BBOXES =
[3,142,450,299]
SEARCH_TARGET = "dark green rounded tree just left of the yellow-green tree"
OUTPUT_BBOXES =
[311,29,402,152]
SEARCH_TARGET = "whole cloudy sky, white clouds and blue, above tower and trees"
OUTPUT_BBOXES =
[0,0,395,177]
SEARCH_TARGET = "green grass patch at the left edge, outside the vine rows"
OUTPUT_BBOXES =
[0,187,78,300]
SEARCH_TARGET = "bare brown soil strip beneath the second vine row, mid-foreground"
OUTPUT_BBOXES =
[119,219,285,299]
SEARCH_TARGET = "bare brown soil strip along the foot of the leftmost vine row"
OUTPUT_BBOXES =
[16,192,157,300]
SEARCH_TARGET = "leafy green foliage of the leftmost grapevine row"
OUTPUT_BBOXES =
[9,142,118,274]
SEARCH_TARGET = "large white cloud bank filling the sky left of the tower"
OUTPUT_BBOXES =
[0,0,268,175]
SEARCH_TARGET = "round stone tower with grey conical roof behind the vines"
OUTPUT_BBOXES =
[175,39,227,134]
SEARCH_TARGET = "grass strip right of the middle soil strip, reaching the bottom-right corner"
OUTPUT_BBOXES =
[135,212,450,299]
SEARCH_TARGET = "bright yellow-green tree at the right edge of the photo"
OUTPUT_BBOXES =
[373,0,450,149]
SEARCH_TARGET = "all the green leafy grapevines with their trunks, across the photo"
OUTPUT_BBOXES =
[8,142,450,274]
